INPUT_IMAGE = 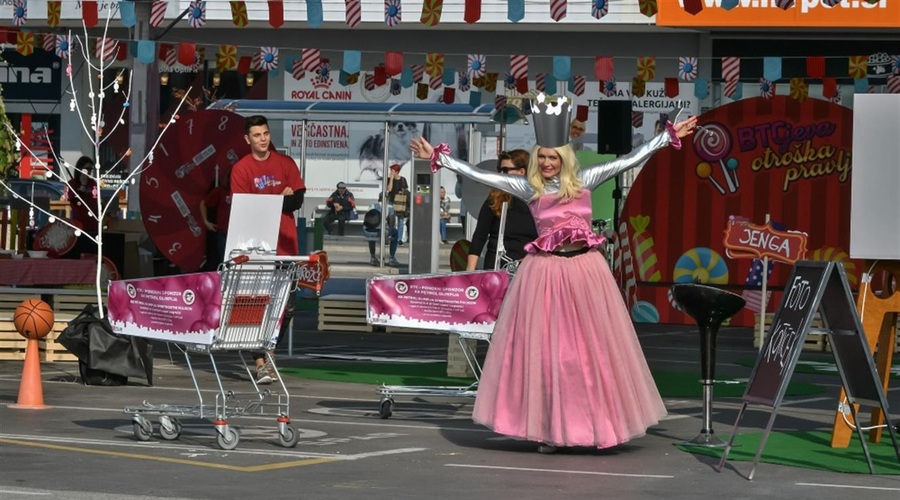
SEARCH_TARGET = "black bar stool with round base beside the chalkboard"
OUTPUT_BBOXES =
[672,283,746,447]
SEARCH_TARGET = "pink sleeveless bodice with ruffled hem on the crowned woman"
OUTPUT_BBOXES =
[525,191,606,253]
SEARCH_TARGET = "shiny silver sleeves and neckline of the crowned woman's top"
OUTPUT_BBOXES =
[437,131,671,202]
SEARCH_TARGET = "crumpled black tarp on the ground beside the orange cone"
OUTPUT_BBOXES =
[57,304,153,385]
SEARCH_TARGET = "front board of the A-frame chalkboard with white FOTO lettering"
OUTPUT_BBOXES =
[743,261,828,406]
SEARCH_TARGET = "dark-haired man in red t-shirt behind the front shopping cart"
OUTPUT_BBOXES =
[231,115,306,384]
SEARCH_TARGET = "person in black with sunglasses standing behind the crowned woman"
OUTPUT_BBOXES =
[466,149,537,271]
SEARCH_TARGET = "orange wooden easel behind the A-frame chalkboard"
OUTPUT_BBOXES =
[831,260,900,448]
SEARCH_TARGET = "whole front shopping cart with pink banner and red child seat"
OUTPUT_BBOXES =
[109,255,316,450]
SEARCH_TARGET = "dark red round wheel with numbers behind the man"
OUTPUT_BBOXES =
[140,110,250,272]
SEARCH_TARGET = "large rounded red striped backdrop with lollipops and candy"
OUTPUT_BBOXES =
[615,96,860,326]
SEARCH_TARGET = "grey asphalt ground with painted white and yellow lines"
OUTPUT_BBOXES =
[0,308,900,500]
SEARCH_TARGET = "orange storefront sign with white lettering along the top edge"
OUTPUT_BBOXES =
[656,0,900,29]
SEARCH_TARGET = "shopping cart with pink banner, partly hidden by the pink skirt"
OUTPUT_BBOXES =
[366,269,510,418]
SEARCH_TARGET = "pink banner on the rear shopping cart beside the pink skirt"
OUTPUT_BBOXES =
[366,271,509,333]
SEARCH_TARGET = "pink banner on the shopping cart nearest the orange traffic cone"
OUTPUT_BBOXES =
[109,272,222,344]
